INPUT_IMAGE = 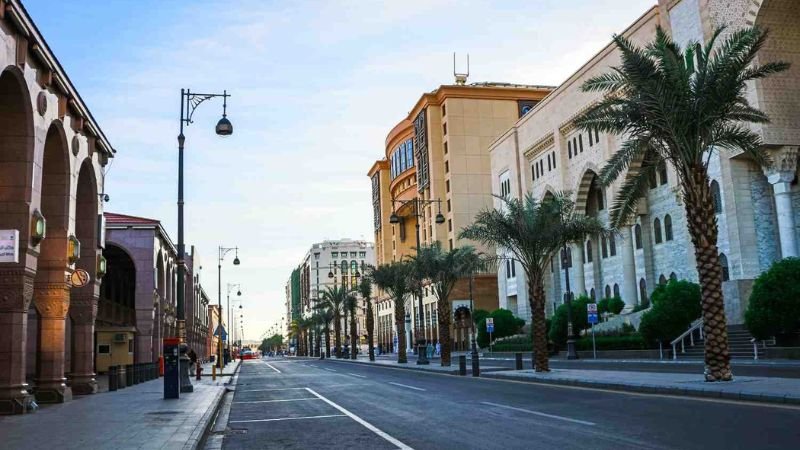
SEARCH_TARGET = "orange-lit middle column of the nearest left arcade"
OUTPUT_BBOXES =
[33,269,72,403]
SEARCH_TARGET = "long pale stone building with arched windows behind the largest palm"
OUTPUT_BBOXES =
[489,0,800,324]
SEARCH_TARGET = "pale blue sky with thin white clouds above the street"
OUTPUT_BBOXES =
[23,0,656,339]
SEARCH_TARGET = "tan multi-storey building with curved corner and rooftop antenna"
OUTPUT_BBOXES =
[368,79,551,350]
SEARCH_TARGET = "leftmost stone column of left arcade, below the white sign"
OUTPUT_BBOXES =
[0,268,36,414]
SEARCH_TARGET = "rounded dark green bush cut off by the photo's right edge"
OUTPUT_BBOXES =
[744,258,800,339]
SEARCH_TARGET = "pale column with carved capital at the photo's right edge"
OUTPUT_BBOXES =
[765,146,798,258]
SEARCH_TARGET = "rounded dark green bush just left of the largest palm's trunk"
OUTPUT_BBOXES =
[639,280,700,343]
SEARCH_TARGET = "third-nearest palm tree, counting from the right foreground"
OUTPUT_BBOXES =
[409,241,481,366]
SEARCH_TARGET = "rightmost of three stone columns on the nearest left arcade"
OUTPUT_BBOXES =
[69,283,99,395]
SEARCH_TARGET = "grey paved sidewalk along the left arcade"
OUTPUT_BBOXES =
[0,361,240,450]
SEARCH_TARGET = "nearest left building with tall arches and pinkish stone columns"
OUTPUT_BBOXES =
[0,0,115,414]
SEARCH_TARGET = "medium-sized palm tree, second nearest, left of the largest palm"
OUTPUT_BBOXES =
[459,193,608,372]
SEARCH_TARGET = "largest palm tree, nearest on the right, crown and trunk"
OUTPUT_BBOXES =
[576,28,789,381]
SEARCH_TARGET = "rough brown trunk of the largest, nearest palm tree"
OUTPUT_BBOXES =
[683,169,733,381]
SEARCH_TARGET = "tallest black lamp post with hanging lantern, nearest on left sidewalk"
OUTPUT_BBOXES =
[169,89,233,398]
